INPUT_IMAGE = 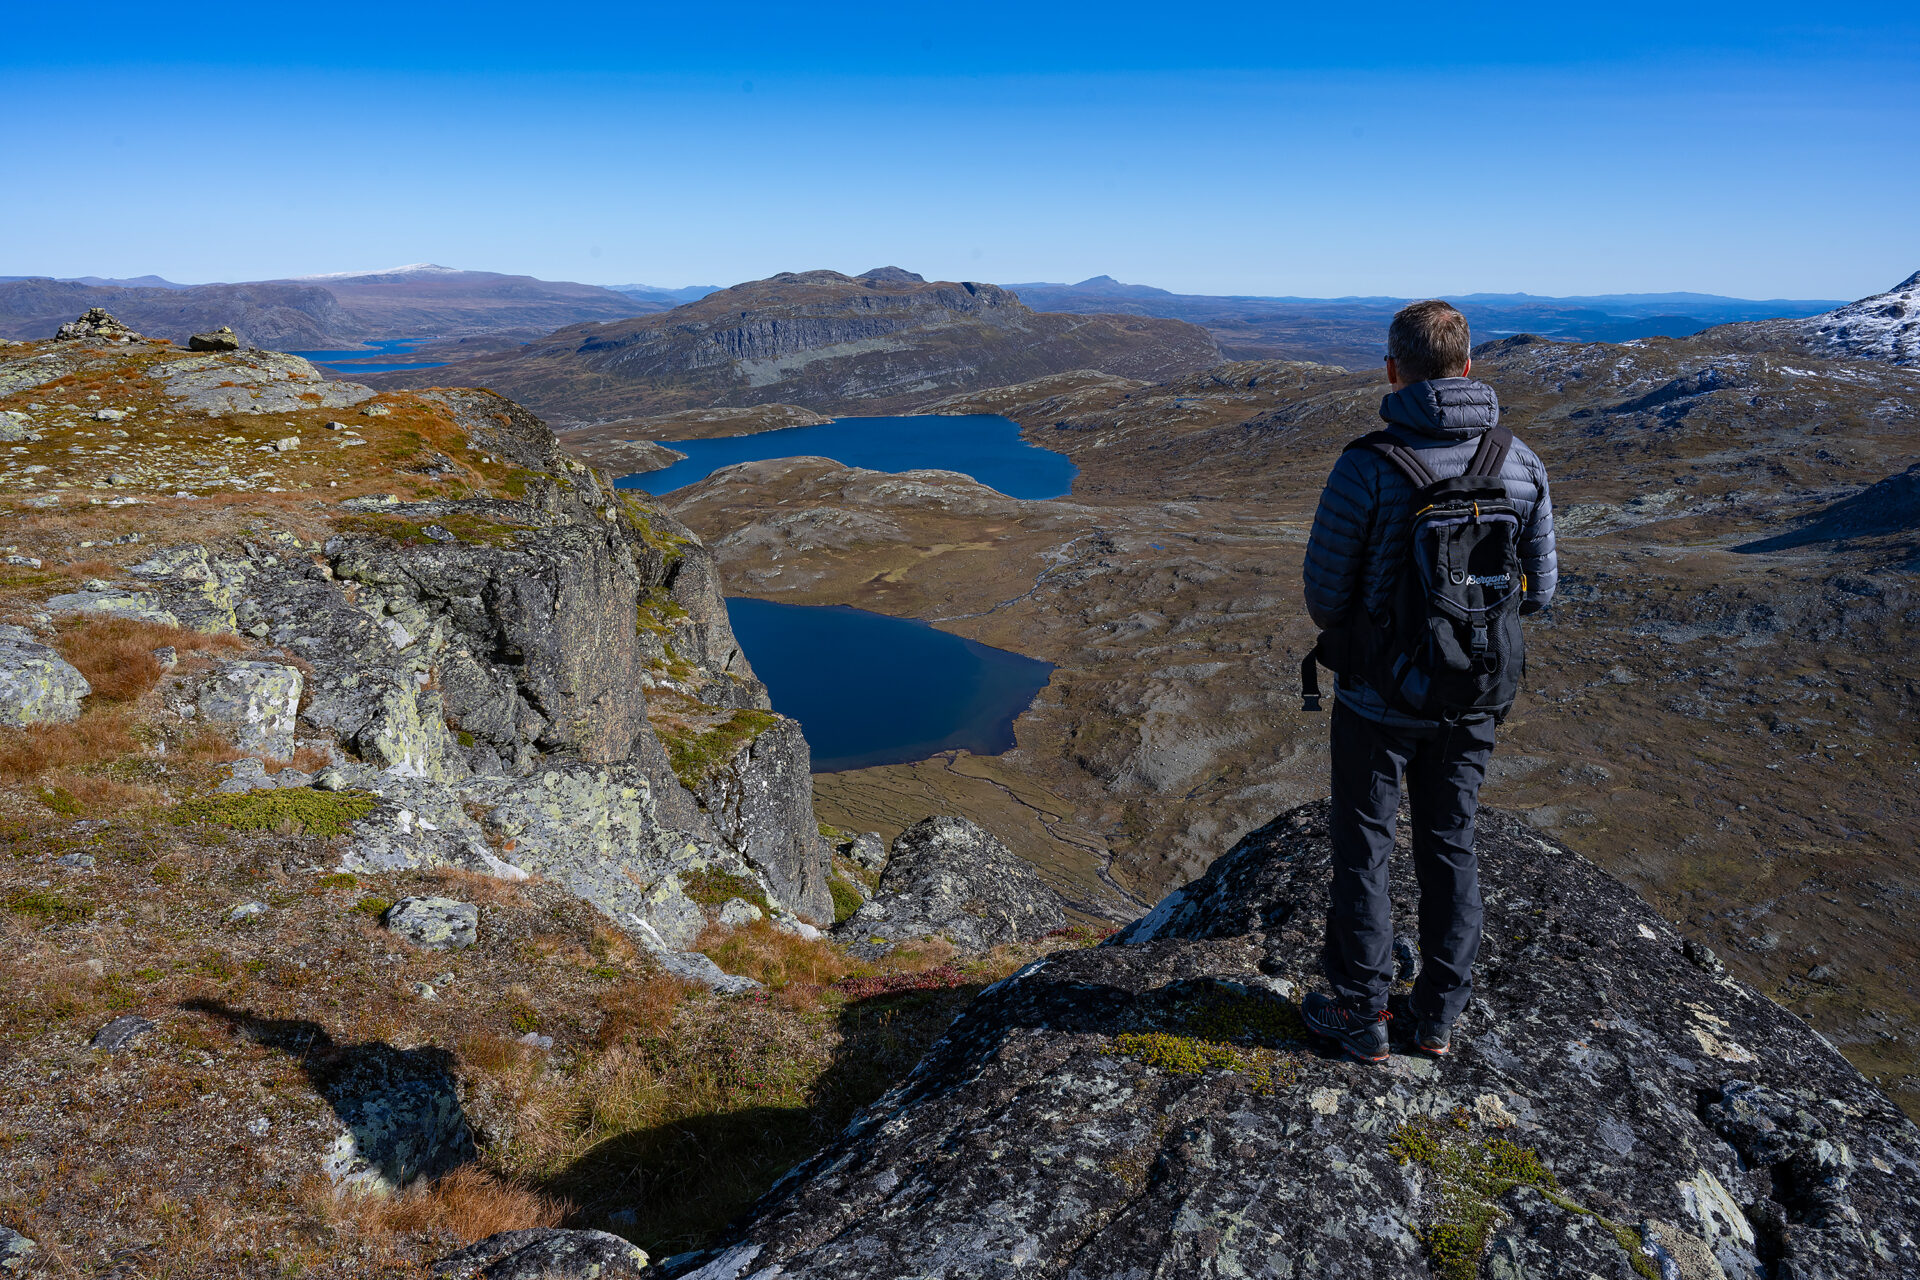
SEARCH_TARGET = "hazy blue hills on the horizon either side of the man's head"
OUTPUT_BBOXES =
[1006,276,1837,367]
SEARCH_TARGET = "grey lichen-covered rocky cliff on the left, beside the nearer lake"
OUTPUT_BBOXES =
[0,320,831,986]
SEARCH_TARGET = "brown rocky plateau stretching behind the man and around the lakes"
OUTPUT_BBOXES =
[668,330,1920,1111]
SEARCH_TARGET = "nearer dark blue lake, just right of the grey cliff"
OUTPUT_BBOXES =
[726,597,1054,773]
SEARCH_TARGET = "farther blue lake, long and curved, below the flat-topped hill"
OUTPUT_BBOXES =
[618,413,1079,502]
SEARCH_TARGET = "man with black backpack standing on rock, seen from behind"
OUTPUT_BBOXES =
[1302,301,1557,1063]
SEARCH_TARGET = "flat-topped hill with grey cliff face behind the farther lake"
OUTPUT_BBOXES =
[369,267,1219,424]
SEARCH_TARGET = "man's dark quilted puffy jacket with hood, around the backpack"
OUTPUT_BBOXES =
[1306,378,1559,720]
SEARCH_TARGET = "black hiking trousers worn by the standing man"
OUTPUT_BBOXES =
[1321,700,1494,1023]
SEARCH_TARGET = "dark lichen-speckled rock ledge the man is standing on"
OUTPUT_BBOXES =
[660,804,1920,1280]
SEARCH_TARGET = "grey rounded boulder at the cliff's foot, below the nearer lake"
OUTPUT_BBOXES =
[835,818,1068,952]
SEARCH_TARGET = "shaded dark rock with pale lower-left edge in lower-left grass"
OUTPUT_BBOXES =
[313,1044,474,1194]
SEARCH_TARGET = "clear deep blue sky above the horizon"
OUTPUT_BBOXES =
[0,0,1920,297]
